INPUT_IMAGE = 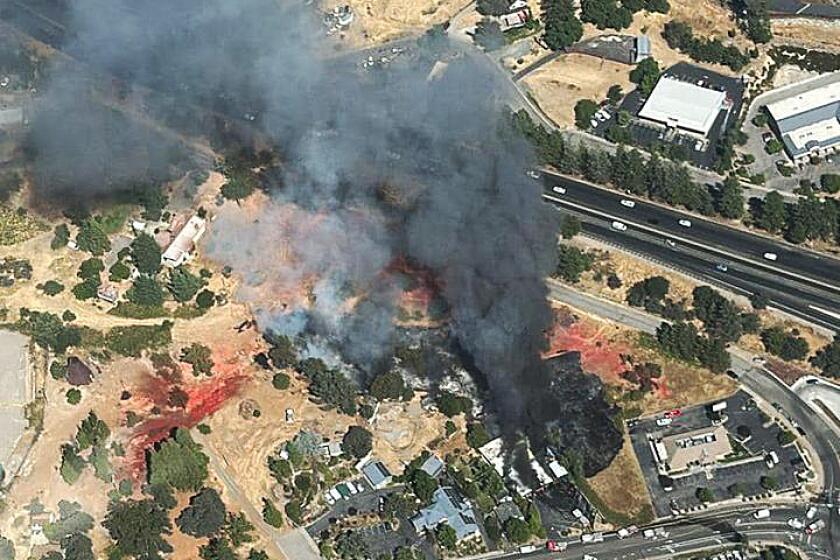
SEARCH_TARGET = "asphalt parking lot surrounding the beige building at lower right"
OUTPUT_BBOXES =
[629,391,805,516]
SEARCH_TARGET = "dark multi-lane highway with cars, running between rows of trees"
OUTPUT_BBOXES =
[544,174,840,332]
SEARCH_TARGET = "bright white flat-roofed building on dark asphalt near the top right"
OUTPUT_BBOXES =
[639,76,726,136]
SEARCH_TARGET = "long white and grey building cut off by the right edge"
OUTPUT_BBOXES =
[767,77,840,162]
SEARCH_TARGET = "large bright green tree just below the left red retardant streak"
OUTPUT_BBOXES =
[149,428,208,492]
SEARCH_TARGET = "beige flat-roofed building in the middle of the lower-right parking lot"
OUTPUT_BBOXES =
[651,425,732,473]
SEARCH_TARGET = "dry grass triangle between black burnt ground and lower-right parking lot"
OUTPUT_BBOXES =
[587,435,653,518]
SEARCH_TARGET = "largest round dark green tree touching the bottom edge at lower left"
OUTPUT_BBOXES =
[102,499,172,560]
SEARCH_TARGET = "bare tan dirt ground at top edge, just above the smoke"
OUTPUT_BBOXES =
[323,0,470,47]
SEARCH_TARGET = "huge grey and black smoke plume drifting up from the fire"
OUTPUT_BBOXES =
[27,0,616,474]
